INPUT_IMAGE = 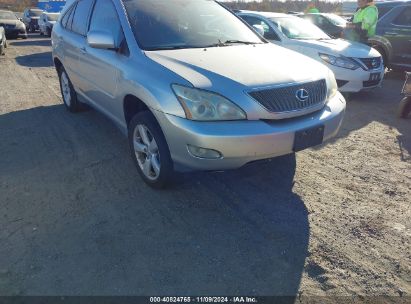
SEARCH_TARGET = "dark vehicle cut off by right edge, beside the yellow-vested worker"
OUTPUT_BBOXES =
[369,2,411,69]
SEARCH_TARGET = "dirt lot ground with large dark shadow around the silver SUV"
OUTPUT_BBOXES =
[0,36,411,302]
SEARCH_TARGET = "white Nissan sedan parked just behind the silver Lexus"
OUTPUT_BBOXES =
[238,11,384,93]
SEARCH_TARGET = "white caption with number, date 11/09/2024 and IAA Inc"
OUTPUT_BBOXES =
[150,296,258,303]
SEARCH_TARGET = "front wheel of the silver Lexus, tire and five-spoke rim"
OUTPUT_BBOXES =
[128,111,174,189]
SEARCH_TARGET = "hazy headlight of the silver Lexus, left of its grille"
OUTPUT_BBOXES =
[171,84,247,121]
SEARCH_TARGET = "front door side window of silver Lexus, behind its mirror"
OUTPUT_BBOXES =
[90,0,123,46]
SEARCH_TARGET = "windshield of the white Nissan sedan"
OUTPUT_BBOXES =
[270,17,331,40]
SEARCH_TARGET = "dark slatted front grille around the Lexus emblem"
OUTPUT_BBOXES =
[249,79,327,113]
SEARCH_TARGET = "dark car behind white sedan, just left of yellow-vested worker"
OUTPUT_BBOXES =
[298,13,347,38]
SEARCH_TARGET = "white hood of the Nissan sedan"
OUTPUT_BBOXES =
[298,39,380,58]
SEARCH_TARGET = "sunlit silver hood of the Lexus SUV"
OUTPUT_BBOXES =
[146,43,328,89]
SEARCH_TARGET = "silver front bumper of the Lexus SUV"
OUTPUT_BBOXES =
[154,93,345,171]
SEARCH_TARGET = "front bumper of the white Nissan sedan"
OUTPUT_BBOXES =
[327,65,384,93]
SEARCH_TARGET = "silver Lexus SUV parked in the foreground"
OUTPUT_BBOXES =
[52,0,345,187]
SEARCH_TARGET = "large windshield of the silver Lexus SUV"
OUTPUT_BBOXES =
[124,0,263,50]
